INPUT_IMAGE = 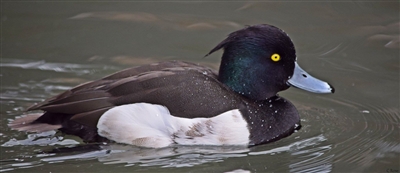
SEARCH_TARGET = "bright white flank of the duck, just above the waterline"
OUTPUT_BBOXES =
[97,103,250,148]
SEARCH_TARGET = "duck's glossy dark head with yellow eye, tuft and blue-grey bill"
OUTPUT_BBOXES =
[206,24,334,100]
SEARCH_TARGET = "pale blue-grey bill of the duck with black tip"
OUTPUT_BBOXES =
[288,62,335,93]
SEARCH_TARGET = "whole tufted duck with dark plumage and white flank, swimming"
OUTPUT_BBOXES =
[10,25,333,147]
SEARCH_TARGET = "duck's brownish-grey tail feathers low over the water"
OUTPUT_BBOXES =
[8,113,61,133]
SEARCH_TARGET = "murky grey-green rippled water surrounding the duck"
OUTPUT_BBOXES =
[0,1,400,172]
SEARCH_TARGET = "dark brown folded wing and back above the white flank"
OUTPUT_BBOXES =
[28,61,241,128]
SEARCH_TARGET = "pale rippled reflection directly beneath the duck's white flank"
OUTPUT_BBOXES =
[99,146,248,167]
